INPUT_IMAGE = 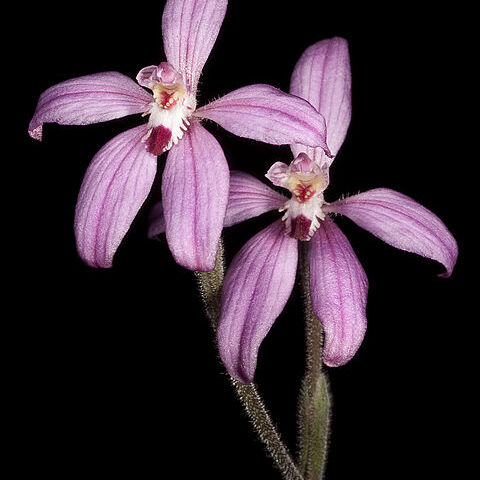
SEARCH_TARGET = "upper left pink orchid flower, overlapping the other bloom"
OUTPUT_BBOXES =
[29,0,328,270]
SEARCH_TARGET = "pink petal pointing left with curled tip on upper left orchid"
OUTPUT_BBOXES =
[28,72,153,140]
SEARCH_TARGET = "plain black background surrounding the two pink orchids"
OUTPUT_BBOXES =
[14,0,472,480]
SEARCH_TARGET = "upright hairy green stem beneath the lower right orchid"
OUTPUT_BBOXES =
[298,244,330,480]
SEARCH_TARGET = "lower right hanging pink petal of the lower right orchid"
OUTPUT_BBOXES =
[308,217,368,367]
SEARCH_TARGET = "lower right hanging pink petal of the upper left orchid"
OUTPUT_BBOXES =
[162,122,229,271]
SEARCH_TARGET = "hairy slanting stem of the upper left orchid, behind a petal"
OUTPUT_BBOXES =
[195,241,303,480]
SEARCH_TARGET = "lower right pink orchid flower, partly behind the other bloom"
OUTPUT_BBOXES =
[150,38,457,383]
